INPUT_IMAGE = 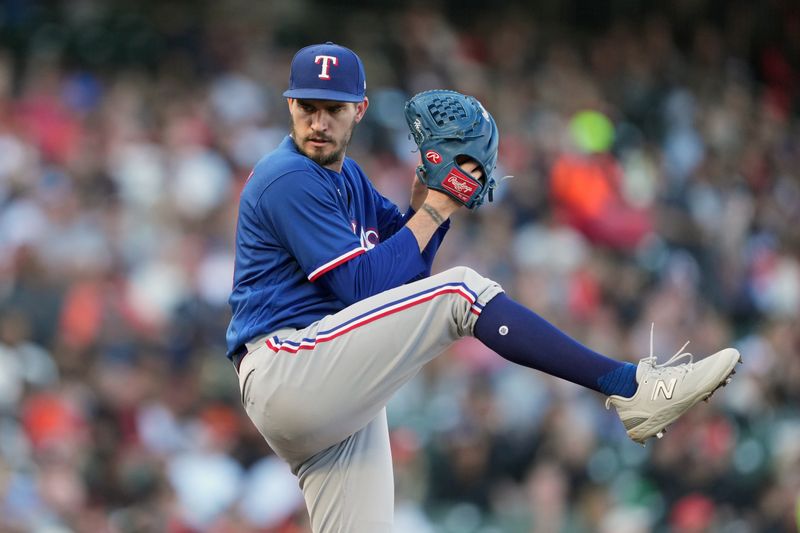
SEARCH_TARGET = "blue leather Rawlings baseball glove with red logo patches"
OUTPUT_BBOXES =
[405,90,500,209]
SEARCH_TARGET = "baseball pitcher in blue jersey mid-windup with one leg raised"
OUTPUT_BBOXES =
[227,43,740,533]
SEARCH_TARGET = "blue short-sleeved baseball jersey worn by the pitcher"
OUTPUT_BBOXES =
[227,136,412,358]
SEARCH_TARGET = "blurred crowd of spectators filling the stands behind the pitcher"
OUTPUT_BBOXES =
[0,0,800,533]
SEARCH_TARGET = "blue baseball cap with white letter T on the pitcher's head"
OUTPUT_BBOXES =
[283,41,367,102]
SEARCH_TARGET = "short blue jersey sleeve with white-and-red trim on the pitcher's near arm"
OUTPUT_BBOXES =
[259,171,367,281]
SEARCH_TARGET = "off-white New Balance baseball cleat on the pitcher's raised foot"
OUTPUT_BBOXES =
[606,330,742,445]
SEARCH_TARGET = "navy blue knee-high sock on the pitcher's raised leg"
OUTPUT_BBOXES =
[473,293,638,397]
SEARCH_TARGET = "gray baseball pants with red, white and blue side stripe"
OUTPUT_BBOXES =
[234,267,502,533]
